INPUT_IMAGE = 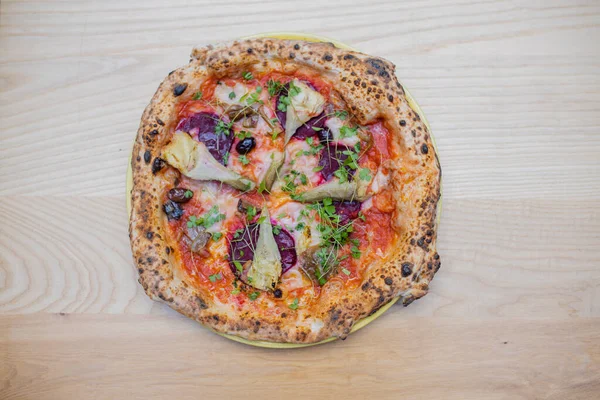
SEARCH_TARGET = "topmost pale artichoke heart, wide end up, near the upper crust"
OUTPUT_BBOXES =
[285,79,325,144]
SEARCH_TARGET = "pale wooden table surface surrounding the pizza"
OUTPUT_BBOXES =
[0,0,600,399]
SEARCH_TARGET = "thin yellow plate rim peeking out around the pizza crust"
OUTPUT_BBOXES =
[126,32,442,349]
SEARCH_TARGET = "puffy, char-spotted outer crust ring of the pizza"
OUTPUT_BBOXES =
[130,39,441,343]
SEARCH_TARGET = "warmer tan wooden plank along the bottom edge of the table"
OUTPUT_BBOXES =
[0,312,600,400]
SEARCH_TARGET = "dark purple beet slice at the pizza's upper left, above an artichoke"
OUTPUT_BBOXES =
[176,112,233,165]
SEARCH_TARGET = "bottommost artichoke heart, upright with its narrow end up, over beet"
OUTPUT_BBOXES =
[247,207,282,290]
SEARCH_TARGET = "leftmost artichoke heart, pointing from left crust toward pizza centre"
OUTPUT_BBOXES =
[162,131,254,190]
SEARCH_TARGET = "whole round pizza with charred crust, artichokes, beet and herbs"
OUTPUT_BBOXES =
[130,38,441,343]
